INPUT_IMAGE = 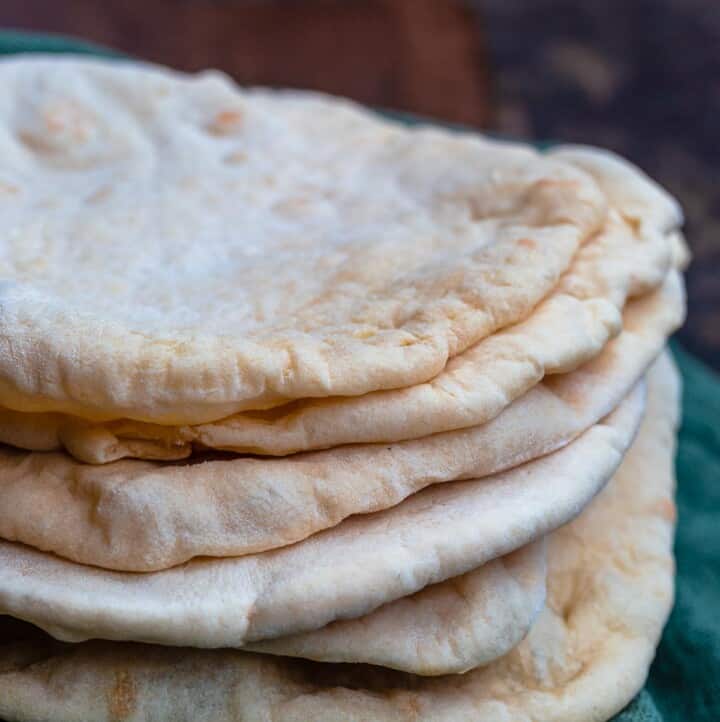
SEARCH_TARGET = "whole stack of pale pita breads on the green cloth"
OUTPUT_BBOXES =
[0,57,687,722]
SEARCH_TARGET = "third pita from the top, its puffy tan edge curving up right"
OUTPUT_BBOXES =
[0,275,684,571]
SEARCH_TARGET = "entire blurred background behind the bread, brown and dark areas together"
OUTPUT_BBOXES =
[0,0,720,369]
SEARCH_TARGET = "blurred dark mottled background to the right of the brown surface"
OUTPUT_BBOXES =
[472,0,720,370]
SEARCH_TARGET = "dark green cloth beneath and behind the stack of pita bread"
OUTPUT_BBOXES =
[0,32,720,722]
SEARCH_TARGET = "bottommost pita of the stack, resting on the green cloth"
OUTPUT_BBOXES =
[0,358,678,722]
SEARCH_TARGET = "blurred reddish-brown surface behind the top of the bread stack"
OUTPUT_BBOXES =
[0,0,488,125]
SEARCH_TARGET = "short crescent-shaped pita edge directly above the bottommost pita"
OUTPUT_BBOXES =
[247,540,547,675]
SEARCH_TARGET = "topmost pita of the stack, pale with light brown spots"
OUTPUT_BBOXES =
[0,56,612,424]
